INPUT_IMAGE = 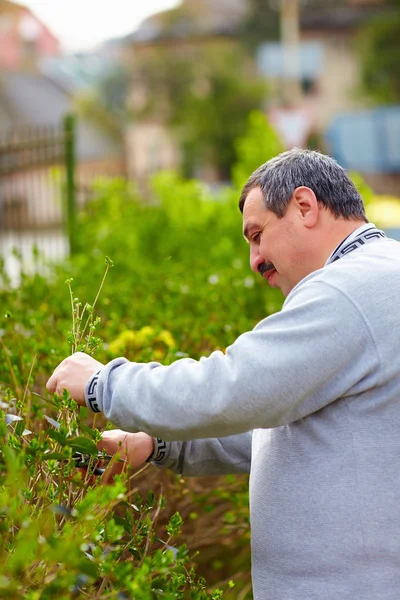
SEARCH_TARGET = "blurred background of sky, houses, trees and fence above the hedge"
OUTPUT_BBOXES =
[0,0,400,278]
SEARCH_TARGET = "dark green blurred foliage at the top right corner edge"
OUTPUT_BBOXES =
[359,0,400,104]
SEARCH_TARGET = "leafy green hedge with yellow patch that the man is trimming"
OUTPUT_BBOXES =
[0,166,281,600]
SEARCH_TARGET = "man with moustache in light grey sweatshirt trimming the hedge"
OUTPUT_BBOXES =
[48,149,400,600]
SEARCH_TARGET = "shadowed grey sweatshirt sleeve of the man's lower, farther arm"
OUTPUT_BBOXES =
[149,431,252,477]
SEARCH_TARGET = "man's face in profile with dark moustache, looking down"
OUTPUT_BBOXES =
[243,187,306,296]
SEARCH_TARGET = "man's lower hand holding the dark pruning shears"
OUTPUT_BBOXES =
[97,429,154,481]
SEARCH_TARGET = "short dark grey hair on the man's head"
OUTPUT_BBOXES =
[239,148,368,223]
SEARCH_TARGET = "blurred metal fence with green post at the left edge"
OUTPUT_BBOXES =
[0,115,77,279]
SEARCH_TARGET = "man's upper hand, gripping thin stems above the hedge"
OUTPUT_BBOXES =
[46,352,104,406]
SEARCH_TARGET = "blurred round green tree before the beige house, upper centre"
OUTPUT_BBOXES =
[136,42,266,178]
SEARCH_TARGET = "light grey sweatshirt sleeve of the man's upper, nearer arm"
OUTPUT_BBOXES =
[86,280,379,441]
